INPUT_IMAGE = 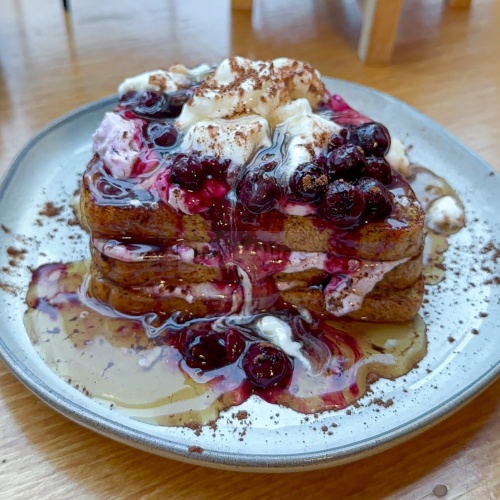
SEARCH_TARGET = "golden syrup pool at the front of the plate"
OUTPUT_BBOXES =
[25,261,427,425]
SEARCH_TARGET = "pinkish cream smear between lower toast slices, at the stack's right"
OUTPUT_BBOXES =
[323,258,408,316]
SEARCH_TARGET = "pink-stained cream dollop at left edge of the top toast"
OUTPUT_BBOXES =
[92,112,142,179]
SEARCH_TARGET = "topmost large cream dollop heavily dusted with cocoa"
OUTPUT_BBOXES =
[177,57,325,130]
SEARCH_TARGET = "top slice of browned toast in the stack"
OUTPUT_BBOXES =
[81,157,425,261]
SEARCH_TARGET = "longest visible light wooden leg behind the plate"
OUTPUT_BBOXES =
[358,0,403,64]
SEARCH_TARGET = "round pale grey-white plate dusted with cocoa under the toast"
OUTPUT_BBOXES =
[0,79,500,471]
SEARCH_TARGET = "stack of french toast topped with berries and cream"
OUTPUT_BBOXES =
[81,58,424,322]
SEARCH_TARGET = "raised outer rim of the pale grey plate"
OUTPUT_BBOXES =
[0,77,500,472]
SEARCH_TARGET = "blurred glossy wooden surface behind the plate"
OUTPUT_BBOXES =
[0,0,500,173]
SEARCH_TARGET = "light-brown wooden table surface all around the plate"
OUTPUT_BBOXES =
[0,0,500,499]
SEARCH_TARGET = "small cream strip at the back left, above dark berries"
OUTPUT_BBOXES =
[118,64,212,97]
